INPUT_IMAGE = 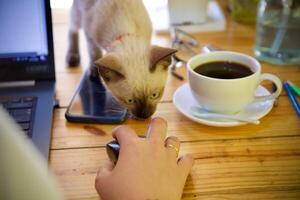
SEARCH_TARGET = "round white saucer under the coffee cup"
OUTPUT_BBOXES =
[173,83,274,127]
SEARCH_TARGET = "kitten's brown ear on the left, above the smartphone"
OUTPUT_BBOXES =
[95,53,125,82]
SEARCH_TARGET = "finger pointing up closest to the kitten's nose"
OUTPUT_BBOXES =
[147,117,167,142]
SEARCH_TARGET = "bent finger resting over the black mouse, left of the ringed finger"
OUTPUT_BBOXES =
[112,126,138,145]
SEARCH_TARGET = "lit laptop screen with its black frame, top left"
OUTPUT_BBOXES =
[0,0,54,81]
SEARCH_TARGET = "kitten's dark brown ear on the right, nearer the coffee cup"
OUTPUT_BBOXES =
[149,45,177,72]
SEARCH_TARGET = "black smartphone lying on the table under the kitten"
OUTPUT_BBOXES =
[65,71,127,124]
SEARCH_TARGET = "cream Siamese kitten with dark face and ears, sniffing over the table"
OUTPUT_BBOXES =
[67,0,176,119]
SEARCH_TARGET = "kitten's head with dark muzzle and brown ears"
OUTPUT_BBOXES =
[95,46,176,119]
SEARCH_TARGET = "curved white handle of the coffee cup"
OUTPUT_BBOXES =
[254,74,282,102]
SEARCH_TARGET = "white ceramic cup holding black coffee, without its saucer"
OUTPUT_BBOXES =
[187,51,282,114]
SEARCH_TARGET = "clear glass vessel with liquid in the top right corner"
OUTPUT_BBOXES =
[255,0,300,64]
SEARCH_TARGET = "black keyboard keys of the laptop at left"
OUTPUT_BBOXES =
[0,96,37,138]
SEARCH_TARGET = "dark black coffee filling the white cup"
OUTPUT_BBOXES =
[194,61,253,79]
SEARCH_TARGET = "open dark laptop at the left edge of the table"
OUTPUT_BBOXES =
[0,0,55,159]
